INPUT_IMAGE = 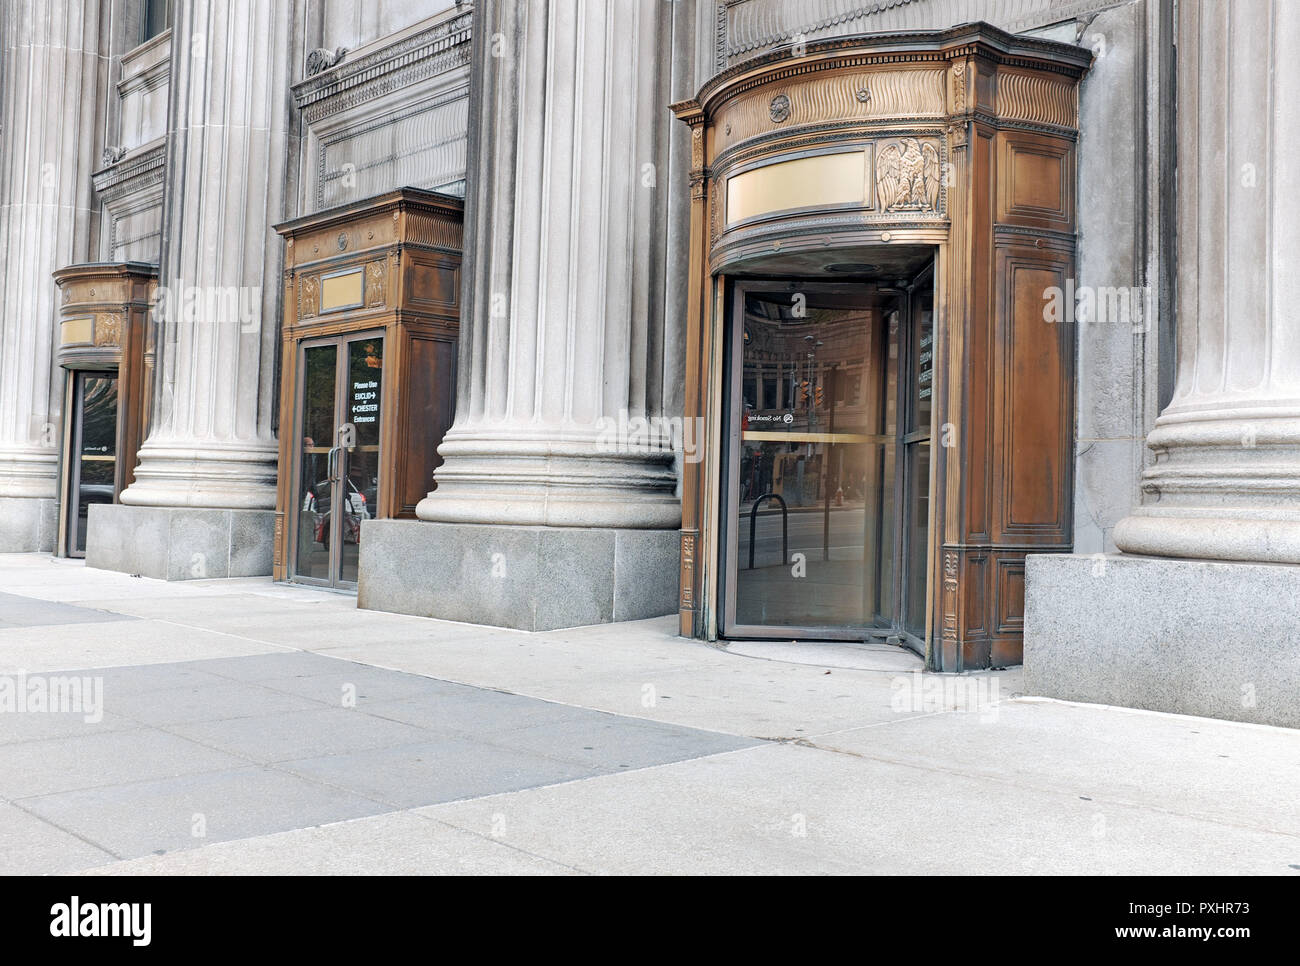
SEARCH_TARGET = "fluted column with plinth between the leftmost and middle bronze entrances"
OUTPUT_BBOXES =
[87,0,293,577]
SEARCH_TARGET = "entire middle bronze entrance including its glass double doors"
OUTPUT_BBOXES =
[273,189,463,589]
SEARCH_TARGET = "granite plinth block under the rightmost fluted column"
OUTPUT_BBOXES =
[1024,554,1300,728]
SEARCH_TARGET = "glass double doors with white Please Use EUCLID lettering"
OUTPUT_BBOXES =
[290,334,384,588]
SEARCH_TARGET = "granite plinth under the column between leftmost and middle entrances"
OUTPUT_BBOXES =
[86,503,276,580]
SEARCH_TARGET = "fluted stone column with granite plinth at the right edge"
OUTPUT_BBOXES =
[1024,0,1300,728]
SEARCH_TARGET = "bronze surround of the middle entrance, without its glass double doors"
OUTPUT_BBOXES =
[273,189,464,580]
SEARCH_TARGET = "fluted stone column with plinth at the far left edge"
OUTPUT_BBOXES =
[0,0,107,553]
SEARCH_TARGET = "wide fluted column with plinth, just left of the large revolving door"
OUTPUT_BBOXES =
[359,0,694,631]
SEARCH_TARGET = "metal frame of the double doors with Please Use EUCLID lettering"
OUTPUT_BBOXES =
[285,325,389,593]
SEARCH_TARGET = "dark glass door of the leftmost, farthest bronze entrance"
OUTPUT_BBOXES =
[66,372,117,556]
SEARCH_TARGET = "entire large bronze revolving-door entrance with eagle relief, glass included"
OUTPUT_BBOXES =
[672,23,1092,671]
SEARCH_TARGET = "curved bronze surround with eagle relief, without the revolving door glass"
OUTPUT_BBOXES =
[672,23,1091,671]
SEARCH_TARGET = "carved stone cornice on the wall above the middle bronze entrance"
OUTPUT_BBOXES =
[293,4,473,124]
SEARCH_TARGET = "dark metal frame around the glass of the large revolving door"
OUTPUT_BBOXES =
[714,275,940,644]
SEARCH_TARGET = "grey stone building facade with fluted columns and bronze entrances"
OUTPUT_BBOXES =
[0,0,1300,724]
